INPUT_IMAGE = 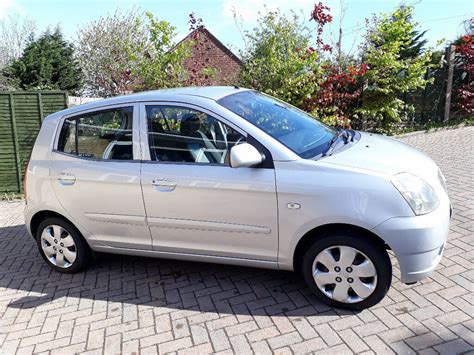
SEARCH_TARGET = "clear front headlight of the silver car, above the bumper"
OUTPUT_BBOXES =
[392,173,439,216]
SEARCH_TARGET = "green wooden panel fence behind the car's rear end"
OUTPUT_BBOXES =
[0,91,67,193]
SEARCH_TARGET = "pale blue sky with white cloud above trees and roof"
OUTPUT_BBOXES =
[0,0,474,53]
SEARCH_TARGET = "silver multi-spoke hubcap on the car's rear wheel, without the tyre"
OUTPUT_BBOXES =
[41,225,77,269]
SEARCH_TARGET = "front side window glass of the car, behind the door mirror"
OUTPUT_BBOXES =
[146,105,245,165]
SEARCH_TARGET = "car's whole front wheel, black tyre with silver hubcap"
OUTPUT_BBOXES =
[301,232,392,311]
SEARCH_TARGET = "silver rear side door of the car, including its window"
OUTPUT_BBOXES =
[50,104,152,249]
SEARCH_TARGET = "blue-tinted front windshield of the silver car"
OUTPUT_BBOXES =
[218,91,337,159]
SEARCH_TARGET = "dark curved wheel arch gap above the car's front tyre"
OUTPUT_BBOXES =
[293,223,390,272]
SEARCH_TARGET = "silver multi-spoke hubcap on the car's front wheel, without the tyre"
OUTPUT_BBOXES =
[312,245,377,303]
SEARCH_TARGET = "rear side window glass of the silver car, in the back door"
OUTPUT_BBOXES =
[58,107,133,160]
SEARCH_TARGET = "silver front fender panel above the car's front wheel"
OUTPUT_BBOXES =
[275,160,413,270]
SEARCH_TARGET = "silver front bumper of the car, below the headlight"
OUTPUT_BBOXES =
[373,198,452,283]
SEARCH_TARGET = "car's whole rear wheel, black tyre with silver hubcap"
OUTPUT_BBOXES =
[36,217,92,274]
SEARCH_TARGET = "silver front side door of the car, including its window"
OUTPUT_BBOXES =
[141,105,278,261]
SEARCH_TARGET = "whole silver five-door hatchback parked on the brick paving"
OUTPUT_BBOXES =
[25,87,451,309]
